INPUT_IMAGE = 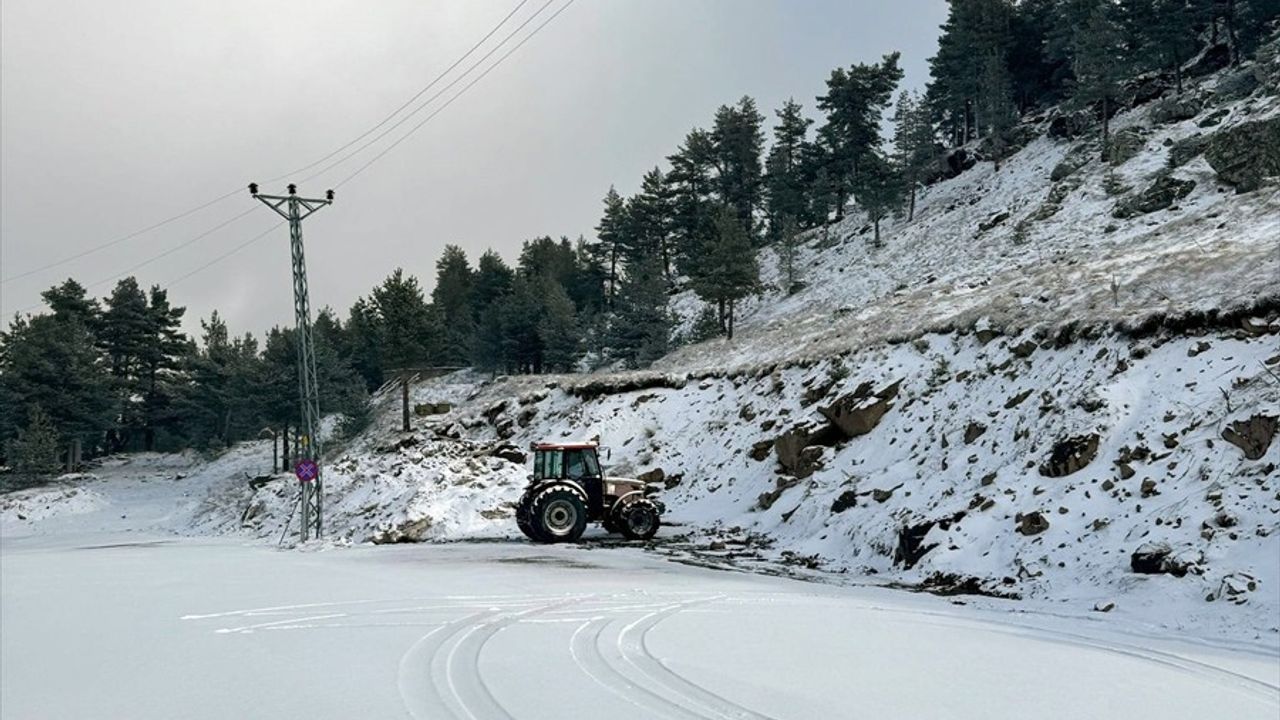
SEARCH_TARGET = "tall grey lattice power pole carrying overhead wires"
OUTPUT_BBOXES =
[248,182,333,542]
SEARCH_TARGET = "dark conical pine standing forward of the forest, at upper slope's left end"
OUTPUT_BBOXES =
[692,208,759,340]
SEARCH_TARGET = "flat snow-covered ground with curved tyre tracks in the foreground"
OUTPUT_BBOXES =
[0,533,1280,720]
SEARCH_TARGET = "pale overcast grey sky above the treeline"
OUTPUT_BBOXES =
[0,0,946,332]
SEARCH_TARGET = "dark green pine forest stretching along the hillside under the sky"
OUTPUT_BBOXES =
[0,0,1280,477]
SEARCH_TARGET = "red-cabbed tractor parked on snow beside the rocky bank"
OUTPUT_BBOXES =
[516,442,666,543]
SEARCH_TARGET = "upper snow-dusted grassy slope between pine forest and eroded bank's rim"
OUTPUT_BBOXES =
[659,60,1280,370]
